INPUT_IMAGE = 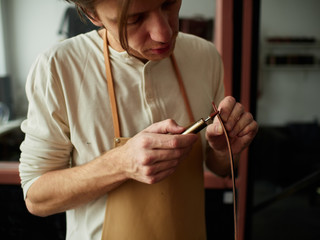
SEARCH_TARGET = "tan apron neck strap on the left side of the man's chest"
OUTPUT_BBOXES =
[103,30,121,138]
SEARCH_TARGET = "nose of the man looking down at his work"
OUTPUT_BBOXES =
[148,10,172,43]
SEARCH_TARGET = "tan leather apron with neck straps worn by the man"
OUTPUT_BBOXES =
[102,31,206,240]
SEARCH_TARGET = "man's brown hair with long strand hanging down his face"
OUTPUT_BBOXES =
[65,0,131,52]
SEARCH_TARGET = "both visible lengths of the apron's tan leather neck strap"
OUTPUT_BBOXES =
[103,29,194,138]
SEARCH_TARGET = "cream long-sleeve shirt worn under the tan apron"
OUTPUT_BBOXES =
[19,31,224,240]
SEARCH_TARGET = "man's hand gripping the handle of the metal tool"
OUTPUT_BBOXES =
[114,119,197,184]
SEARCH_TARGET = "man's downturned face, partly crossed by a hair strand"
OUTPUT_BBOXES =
[96,0,181,61]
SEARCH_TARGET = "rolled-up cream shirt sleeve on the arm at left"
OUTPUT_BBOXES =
[19,55,72,198]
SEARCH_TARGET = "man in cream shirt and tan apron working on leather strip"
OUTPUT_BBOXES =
[20,0,257,239]
